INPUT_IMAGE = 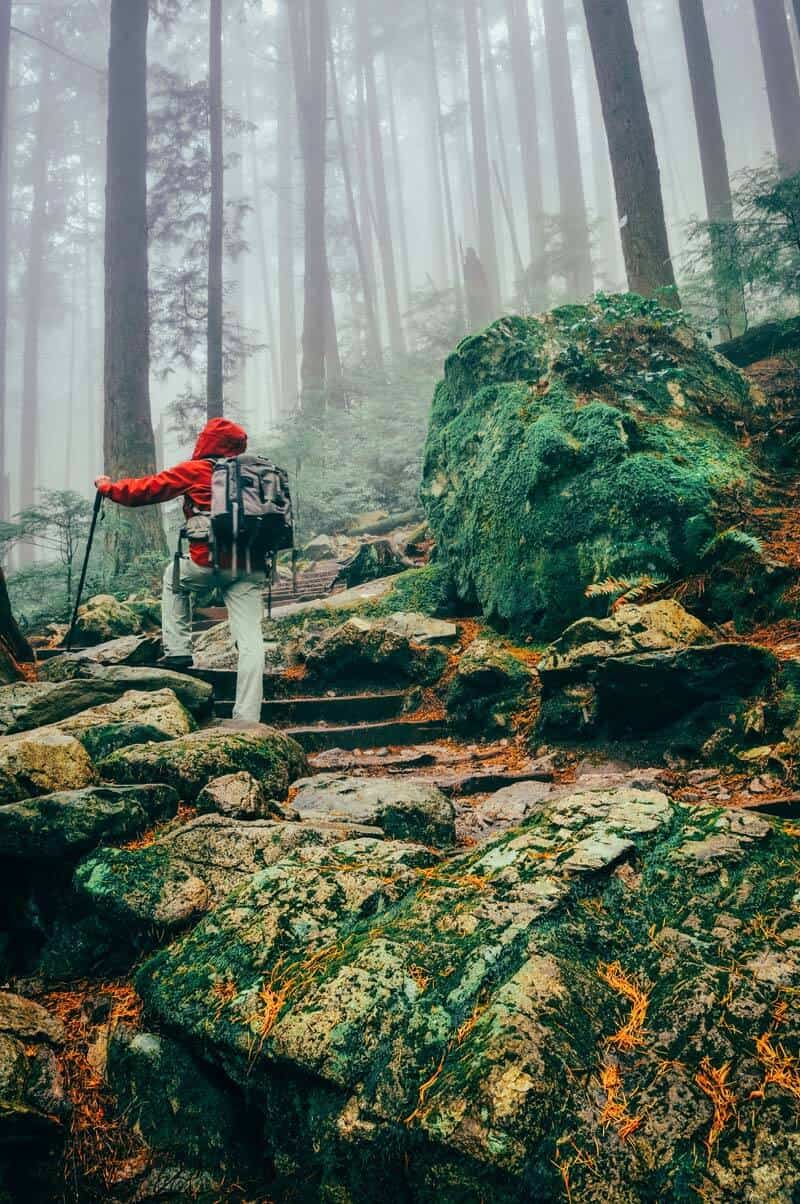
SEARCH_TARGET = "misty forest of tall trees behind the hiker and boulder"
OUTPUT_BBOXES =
[0,0,800,624]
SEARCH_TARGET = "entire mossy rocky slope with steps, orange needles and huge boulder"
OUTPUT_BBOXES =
[0,302,800,1204]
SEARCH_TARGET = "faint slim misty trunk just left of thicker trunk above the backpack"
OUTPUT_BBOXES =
[277,15,298,412]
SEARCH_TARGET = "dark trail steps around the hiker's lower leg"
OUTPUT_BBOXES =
[192,668,446,753]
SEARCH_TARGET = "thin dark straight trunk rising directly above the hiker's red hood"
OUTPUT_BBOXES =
[206,0,225,418]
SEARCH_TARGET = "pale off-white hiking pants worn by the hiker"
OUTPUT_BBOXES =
[161,556,264,724]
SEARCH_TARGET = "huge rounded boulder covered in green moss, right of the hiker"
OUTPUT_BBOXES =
[422,296,766,636]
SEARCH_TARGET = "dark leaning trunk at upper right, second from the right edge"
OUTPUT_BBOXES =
[680,0,746,338]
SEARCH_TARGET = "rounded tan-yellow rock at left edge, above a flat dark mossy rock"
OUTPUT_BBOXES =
[0,731,96,805]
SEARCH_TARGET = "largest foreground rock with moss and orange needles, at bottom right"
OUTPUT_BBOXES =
[137,790,800,1204]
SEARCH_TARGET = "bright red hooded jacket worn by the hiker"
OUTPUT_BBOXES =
[100,418,247,567]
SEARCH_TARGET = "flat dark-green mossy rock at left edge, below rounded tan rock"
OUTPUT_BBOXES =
[0,785,178,862]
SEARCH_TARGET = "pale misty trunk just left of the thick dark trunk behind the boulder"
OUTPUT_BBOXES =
[542,0,594,300]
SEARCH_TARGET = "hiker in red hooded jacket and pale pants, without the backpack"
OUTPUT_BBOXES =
[94,418,265,722]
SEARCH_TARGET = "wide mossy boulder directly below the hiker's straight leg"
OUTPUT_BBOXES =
[99,725,308,801]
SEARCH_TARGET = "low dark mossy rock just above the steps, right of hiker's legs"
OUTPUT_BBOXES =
[302,618,447,684]
